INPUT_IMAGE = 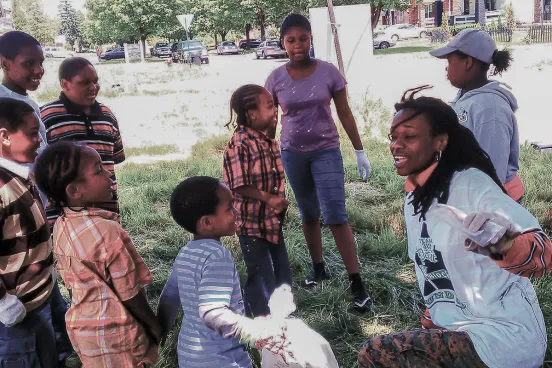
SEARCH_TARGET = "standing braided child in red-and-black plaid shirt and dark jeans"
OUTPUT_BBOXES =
[223,85,291,316]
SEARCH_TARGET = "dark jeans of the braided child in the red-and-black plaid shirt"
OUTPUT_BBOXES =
[239,232,291,317]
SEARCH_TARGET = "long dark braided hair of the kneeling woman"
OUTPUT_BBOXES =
[393,85,505,217]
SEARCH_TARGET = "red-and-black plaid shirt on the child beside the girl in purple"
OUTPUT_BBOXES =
[223,126,285,244]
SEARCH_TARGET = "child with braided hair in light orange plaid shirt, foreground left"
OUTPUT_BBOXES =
[35,141,161,368]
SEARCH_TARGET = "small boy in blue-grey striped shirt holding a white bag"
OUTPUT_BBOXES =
[157,176,281,368]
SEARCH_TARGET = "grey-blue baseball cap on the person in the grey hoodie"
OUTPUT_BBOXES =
[429,28,497,64]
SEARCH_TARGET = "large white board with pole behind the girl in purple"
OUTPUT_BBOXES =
[309,4,374,76]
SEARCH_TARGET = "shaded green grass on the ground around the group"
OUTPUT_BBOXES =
[58,131,552,368]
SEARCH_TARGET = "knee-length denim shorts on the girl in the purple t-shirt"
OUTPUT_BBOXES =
[282,148,349,225]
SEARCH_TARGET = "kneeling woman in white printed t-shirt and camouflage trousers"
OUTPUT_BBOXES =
[359,87,552,368]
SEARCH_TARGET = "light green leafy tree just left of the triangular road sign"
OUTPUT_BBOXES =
[86,0,182,57]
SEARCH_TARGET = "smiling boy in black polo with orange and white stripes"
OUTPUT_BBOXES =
[40,57,125,227]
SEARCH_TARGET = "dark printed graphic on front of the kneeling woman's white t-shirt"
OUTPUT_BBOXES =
[416,221,459,308]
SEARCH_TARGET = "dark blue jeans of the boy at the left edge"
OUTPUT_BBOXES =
[0,283,73,368]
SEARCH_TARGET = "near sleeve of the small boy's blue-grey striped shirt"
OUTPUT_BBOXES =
[198,253,244,338]
